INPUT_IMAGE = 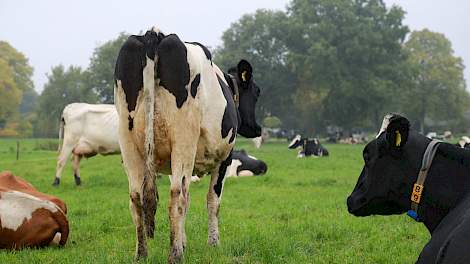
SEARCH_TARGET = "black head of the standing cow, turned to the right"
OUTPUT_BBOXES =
[229,60,261,138]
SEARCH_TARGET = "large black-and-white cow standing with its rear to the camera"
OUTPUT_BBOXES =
[114,28,261,263]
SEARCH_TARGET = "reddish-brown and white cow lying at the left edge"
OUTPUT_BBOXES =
[0,171,69,249]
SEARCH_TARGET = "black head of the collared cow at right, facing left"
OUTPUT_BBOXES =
[347,115,430,216]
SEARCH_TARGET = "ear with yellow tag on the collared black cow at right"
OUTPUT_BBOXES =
[386,115,410,150]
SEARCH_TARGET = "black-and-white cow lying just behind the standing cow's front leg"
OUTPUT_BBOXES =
[191,149,268,182]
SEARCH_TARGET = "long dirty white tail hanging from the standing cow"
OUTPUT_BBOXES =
[142,47,158,238]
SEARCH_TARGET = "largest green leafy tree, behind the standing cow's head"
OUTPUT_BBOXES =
[216,0,408,131]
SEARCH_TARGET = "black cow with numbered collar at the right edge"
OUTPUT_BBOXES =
[347,114,470,263]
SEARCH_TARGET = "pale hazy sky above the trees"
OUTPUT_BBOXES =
[0,0,470,92]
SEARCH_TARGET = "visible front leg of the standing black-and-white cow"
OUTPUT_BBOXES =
[207,153,232,246]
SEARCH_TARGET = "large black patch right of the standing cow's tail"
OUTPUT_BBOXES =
[157,34,189,108]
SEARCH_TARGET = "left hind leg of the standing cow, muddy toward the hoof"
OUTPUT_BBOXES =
[120,135,147,260]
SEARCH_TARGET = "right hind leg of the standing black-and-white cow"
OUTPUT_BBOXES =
[168,147,196,263]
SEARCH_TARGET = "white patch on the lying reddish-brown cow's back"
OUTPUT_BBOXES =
[0,191,58,231]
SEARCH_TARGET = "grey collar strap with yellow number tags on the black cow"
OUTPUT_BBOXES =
[407,139,441,222]
